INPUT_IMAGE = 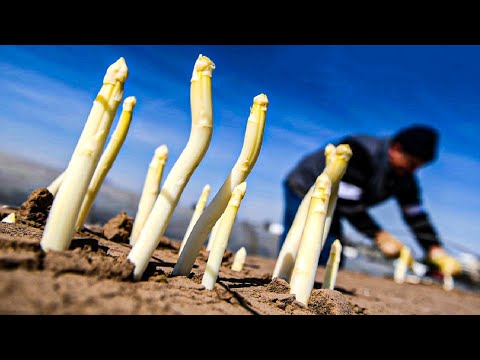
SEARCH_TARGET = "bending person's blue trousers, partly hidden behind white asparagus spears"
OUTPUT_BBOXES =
[277,181,345,267]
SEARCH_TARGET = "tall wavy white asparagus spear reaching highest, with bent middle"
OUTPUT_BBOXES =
[128,55,215,280]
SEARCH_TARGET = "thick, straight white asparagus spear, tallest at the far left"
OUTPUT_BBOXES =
[40,58,128,251]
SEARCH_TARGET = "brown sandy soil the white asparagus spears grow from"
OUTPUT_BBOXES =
[0,192,480,315]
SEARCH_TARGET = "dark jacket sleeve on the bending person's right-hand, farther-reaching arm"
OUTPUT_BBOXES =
[396,176,442,251]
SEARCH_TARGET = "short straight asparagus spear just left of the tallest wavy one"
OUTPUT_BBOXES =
[130,145,168,245]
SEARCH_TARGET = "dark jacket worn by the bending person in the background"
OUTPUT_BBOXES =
[285,135,441,250]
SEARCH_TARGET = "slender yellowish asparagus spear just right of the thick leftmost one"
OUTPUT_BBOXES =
[75,96,137,231]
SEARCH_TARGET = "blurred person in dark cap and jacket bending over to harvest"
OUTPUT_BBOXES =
[278,125,461,275]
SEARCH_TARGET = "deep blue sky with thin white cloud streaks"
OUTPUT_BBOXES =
[0,44,480,255]
